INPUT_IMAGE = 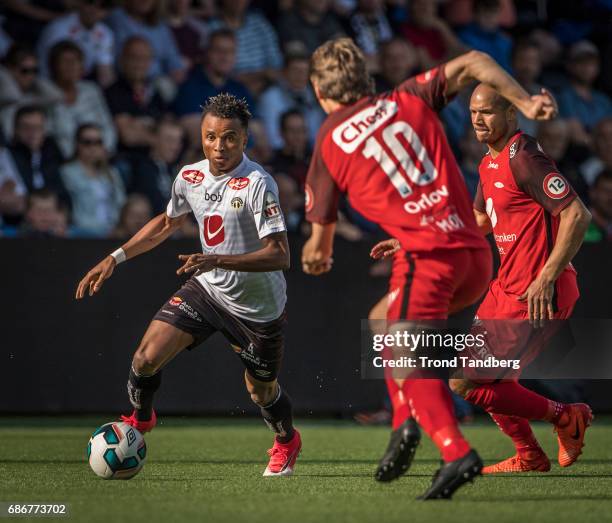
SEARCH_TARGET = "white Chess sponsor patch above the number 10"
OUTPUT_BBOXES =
[332,99,397,154]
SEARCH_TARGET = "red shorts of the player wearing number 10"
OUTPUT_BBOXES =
[387,248,492,320]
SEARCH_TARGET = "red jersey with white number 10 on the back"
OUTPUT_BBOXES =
[306,66,487,252]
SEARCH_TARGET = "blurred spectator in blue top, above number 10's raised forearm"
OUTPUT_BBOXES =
[459,0,512,71]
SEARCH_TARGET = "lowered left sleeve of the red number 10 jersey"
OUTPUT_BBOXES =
[306,135,340,225]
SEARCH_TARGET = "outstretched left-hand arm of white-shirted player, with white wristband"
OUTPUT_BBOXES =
[75,213,186,300]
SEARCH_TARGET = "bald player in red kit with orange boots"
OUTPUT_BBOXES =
[444,84,592,473]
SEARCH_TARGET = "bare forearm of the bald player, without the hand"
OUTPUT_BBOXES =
[541,198,591,282]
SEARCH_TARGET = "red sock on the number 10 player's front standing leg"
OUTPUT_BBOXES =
[404,379,470,462]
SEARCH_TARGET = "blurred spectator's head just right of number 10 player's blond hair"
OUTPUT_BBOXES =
[374,37,419,93]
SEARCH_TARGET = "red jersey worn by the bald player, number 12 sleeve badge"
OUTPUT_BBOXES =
[474,131,578,308]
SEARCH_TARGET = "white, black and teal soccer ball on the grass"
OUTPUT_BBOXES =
[87,421,147,479]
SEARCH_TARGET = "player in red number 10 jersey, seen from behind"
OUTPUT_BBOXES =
[302,38,555,499]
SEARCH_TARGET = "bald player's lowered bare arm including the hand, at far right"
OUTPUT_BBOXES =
[519,198,591,327]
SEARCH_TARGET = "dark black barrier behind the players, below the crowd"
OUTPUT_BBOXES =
[0,239,612,415]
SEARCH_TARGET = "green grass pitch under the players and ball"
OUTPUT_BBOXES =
[0,417,612,523]
